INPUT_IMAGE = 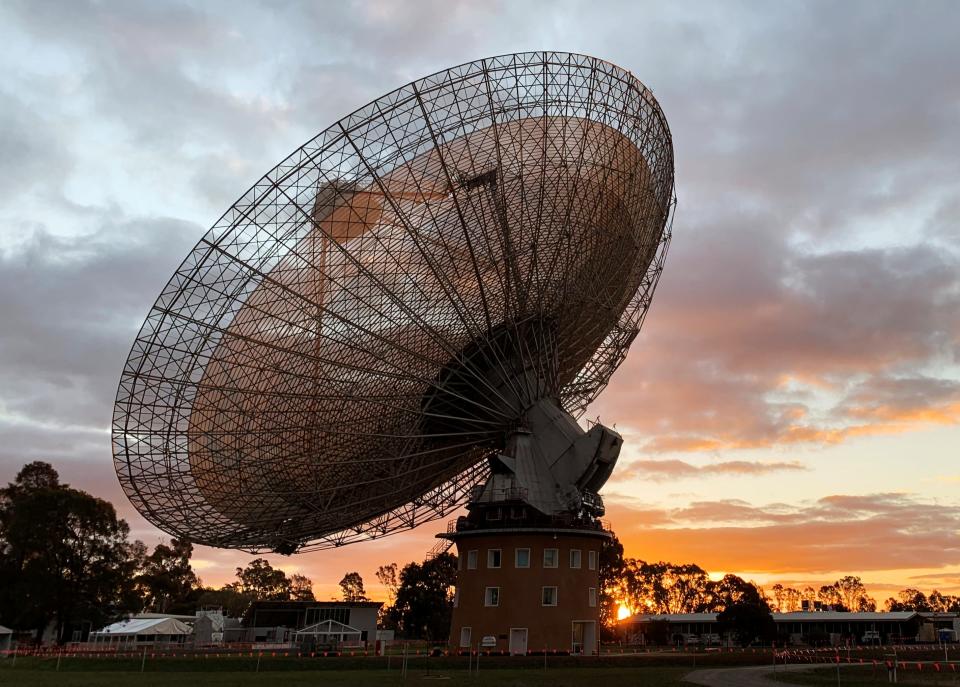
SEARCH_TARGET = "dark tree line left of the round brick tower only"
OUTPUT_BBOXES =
[0,462,457,643]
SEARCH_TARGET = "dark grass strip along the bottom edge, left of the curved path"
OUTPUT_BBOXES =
[0,663,689,687]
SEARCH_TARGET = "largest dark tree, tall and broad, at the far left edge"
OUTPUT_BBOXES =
[0,462,146,642]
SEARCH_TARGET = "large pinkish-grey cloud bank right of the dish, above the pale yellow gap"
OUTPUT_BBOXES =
[597,223,960,452]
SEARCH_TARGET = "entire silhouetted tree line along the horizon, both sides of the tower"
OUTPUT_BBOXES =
[0,462,960,642]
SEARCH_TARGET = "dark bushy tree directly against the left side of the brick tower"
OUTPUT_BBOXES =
[390,553,457,640]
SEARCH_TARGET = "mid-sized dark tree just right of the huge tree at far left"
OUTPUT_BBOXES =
[137,538,200,613]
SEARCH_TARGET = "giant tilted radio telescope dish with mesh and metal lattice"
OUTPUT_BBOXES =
[113,52,674,553]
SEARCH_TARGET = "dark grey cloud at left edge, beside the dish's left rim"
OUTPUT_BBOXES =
[0,217,202,432]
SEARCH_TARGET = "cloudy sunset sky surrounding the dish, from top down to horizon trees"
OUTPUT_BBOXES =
[0,0,960,601]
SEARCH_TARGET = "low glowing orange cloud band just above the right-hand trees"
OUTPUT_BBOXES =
[608,494,960,575]
